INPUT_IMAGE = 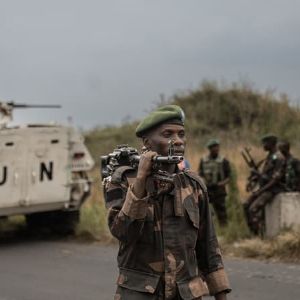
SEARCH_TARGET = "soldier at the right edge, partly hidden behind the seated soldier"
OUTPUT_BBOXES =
[278,141,300,192]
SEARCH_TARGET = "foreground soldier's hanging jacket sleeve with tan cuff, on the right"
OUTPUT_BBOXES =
[196,188,231,295]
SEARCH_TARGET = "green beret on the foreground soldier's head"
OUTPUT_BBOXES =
[135,105,185,137]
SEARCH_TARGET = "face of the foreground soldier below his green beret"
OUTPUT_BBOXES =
[144,124,186,156]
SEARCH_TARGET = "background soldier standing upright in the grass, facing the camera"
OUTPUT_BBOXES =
[199,139,231,225]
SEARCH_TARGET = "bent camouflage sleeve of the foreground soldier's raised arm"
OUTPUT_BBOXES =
[105,178,148,243]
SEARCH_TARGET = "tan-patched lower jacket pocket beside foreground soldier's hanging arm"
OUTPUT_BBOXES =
[177,277,209,300]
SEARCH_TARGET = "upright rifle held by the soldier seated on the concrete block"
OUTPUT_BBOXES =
[241,147,264,192]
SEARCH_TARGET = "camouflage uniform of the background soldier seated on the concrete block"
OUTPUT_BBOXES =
[246,152,286,233]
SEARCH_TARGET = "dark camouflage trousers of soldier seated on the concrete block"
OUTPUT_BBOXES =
[246,191,274,234]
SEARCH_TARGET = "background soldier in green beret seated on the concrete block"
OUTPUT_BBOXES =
[244,134,285,234]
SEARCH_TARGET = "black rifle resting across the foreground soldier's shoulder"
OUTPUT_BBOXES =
[101,140,184,182]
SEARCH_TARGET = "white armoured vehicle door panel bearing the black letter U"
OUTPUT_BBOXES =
[0,129,26,213]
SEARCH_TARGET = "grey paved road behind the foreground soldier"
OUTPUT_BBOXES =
[0,240,300,300]
